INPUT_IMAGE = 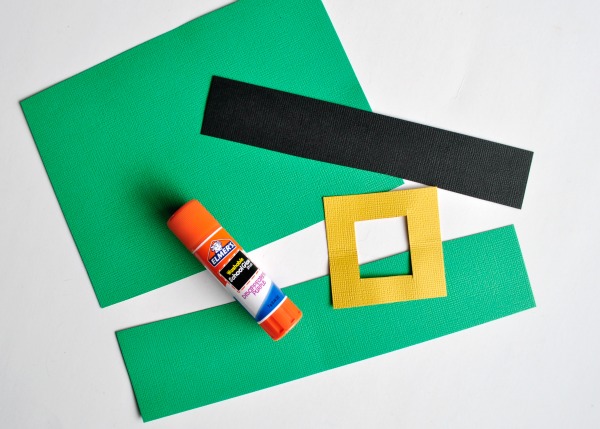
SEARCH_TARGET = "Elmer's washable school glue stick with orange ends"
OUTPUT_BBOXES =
[167,200,302,341]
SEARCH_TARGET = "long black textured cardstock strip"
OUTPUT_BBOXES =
[202,77,533,208]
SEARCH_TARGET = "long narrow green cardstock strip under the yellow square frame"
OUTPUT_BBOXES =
[117,226,535,421]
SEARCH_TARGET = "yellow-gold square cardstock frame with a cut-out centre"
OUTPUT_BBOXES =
[323,188,446,308]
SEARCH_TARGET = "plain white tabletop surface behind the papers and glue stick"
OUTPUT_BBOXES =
[0,0,600,428]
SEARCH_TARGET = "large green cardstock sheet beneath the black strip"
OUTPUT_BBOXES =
[21,0,402,307]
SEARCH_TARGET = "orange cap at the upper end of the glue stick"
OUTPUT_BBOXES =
[167,200,221,252]
